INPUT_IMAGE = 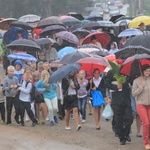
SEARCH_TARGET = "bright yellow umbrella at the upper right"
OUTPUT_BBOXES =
[129,16,150,28]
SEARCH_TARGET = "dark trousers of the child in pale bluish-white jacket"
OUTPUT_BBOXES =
[20,101,37,123]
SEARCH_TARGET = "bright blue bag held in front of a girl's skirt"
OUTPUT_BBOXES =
[91,90,105,107]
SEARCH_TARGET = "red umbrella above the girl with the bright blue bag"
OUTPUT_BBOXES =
[77,56,108,72]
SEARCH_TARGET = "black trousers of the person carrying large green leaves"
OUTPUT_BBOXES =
[112,105,133,139]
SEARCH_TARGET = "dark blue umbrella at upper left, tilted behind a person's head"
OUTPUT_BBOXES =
[4,27,28,44]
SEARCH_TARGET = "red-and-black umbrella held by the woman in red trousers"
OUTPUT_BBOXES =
[120,54,150,76]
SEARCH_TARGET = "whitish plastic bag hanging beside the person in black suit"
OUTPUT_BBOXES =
[102,104,114,120]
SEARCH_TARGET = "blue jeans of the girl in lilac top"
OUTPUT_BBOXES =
[78,96,87,120]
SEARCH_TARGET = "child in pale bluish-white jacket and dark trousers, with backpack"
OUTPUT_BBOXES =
[19,72,37,127]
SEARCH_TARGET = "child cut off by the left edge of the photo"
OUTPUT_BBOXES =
[0,78,5,123]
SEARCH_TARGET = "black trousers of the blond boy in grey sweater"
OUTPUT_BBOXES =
[6,96,20,124]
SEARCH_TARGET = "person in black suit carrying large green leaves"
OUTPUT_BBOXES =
[105,70,133,145]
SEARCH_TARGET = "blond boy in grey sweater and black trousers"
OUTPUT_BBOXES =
[3,66,20,125]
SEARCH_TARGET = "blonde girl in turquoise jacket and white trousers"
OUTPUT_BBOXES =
[35,70,58,126]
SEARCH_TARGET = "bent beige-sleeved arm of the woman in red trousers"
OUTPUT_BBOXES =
[132,80,144,97]
